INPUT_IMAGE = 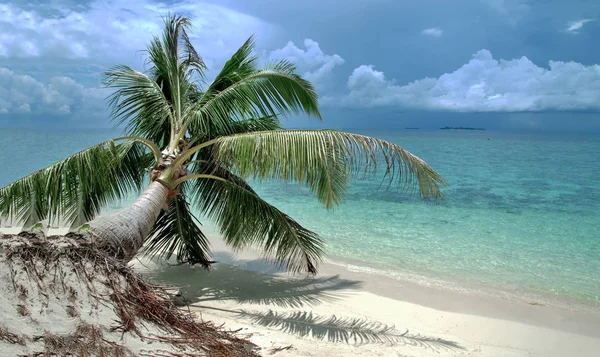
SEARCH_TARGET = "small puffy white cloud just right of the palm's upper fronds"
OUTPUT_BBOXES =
[267,39,344,85]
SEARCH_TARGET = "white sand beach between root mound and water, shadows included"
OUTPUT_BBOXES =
[134,239,600,357]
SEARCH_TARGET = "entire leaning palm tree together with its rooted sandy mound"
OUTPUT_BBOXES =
[0,16,444,356]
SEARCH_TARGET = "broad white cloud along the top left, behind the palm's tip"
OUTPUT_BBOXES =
[0,0,271,64]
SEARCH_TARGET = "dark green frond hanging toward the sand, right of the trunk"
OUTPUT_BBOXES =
[194,168,323,273]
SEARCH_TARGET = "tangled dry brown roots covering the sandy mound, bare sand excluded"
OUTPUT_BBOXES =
[0,234,258,357]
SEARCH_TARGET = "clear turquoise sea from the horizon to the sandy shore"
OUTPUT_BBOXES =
[0,130,600,302]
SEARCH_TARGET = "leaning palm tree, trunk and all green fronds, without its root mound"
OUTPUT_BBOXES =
[0,16,445,273]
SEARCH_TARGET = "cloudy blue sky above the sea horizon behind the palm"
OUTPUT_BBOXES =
[0,0,600,132]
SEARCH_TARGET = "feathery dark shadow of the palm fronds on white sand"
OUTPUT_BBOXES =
[146,252,463,353]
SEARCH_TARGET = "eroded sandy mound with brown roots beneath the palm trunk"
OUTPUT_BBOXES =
[0,233,258,357]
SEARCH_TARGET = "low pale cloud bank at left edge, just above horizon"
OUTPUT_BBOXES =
[0,67,108,116]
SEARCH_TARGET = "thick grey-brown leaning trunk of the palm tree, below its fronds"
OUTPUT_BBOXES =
[87,181,169,261]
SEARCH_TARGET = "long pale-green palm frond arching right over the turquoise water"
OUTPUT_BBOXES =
[204,130,446,208]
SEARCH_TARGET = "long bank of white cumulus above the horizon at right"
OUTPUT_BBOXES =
[322,49,600,112]
